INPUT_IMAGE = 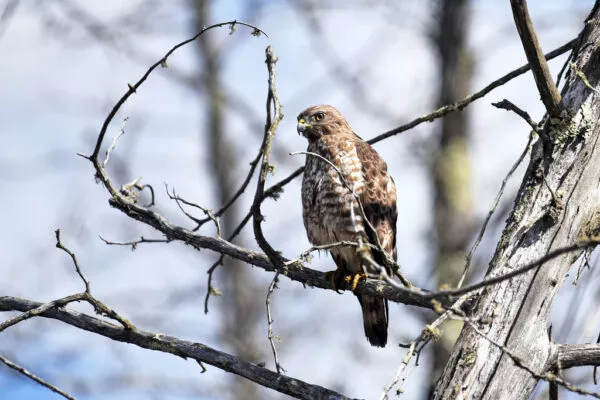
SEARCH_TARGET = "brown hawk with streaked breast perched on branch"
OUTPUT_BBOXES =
[298,105,398,347]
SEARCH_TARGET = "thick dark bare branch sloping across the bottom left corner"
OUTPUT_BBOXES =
[0,296,356,400]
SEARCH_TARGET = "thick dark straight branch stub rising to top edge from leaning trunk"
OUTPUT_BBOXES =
[510,0,562,118]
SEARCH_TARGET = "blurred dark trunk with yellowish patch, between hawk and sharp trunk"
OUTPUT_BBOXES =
[431,0,473,385]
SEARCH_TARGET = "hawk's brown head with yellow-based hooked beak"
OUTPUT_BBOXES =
[297,105,352,141]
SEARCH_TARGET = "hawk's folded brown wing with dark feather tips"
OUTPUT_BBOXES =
[355,135,398,272]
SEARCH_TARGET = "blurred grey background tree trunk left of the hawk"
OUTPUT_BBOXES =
[192,0,266,400]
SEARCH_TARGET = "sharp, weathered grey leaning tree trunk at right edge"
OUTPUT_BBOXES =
[434,4,600,399]
